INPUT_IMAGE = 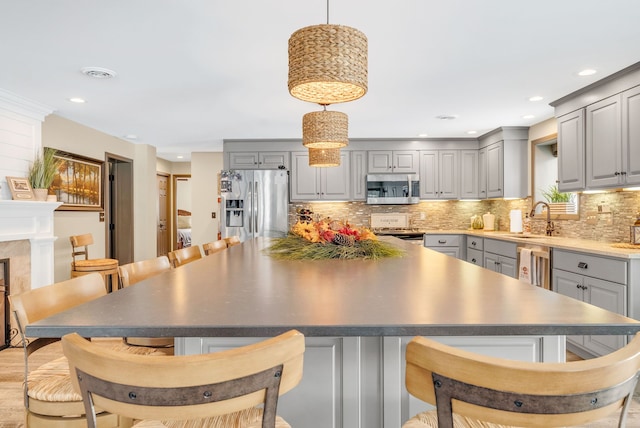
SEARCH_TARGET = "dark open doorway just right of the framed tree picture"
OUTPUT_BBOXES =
[104,153,133,265]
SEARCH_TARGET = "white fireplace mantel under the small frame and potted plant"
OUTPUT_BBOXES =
[0,200,62,289]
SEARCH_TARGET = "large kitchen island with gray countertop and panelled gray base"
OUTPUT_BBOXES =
[27,238,640,428]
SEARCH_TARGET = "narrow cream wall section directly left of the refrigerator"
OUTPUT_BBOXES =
[191,152,222,245]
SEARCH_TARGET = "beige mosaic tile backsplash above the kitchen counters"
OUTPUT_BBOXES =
[289,192,640,242]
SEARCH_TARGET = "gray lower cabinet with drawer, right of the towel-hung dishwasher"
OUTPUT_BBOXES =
[552,250,628,358]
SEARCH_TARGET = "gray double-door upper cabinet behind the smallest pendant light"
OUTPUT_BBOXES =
[290,151,351,201]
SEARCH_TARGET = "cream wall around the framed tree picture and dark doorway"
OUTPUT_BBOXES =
[42,115,158,282]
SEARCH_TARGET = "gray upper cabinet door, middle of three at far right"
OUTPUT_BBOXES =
[585,95,622,188]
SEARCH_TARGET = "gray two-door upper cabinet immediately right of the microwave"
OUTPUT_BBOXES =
[420,150,460,199]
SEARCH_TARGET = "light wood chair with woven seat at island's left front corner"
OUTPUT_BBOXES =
[9,273,138,428]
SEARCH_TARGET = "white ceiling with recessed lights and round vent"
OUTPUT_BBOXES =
[0,0,640,161]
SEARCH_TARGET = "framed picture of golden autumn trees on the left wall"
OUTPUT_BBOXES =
[49,151,104,211]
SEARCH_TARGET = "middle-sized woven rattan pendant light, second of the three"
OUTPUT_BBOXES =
[302,109,349,149]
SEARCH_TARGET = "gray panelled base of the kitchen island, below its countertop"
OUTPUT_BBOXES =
[176,336,564,428]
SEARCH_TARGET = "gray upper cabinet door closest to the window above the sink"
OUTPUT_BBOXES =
[558,109,585,192]
